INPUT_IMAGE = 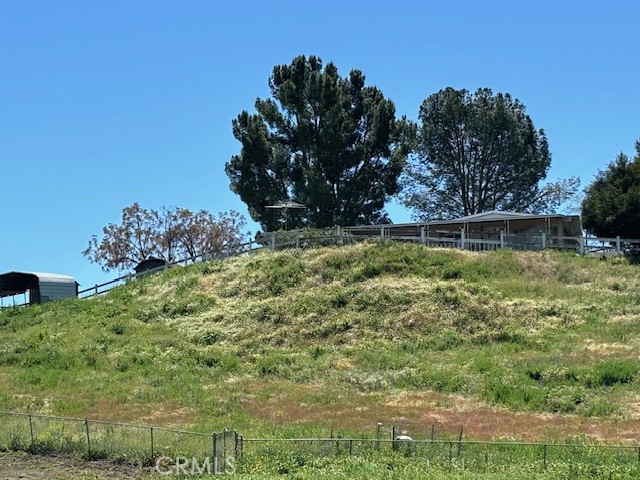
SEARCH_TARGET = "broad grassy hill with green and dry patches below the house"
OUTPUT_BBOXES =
[0,243,640,440]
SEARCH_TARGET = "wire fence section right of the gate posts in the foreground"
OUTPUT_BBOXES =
[236,423,640,472]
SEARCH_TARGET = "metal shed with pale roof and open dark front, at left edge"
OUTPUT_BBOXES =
[0,272,79,305]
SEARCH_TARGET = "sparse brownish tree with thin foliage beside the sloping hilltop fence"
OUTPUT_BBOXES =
[82,203,246,271]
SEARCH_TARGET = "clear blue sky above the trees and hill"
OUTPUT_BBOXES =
[0,0,640,287]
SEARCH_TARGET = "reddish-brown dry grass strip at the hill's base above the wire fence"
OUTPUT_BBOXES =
[243,382,640,442]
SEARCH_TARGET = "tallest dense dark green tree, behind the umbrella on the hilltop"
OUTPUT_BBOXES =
[225,56,415,230]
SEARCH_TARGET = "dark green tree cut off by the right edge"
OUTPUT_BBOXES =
[582,140,640,239]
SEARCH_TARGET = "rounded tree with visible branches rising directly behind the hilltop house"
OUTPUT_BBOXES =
[402,88,579,219]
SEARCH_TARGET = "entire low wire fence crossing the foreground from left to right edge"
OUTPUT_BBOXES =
[0,411,640,471]
